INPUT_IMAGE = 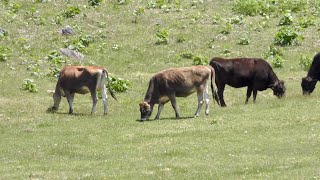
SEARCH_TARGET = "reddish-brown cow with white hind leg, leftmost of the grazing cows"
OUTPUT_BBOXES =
[51,66,116,114]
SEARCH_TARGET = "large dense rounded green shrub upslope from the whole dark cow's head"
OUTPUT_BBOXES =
[274,27,303,46]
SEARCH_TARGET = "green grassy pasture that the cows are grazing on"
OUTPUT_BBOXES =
[0,0,320,179]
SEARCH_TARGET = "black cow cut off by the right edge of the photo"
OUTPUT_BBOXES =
[301,53,320,95]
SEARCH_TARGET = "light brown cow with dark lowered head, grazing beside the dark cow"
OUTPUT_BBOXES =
[139,66,218,121]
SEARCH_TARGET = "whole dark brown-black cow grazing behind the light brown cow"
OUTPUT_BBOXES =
[210,57,286,107]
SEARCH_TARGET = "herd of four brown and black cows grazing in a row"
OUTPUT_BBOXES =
[50,53,320,121]
